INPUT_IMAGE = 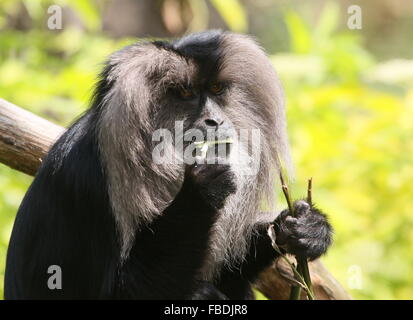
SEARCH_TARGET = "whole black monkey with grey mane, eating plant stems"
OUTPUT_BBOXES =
[5,30,332,299]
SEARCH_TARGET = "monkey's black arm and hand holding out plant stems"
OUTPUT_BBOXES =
[219,200,332,299]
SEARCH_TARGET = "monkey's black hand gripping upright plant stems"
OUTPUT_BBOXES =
[274,200,332,260]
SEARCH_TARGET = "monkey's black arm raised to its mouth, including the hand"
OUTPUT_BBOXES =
[118,165,235,299]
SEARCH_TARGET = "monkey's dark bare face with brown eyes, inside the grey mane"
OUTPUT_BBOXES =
[156,77,238,157]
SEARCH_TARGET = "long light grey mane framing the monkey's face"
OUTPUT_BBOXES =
[98,33,291,280]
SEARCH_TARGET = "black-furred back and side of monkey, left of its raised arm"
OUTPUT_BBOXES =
[5,111,119,299]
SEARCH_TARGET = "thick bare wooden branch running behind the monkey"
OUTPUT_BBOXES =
[0,98,351,300]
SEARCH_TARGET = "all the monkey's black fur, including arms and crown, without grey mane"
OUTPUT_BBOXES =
[5,32,331,299]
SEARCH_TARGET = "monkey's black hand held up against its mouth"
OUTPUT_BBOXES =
[185,164,236,209]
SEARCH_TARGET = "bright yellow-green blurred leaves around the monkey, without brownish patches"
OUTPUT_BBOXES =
[0,0,413,299]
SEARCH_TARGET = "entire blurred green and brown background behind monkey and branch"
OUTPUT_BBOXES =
[0,0,413,299]
